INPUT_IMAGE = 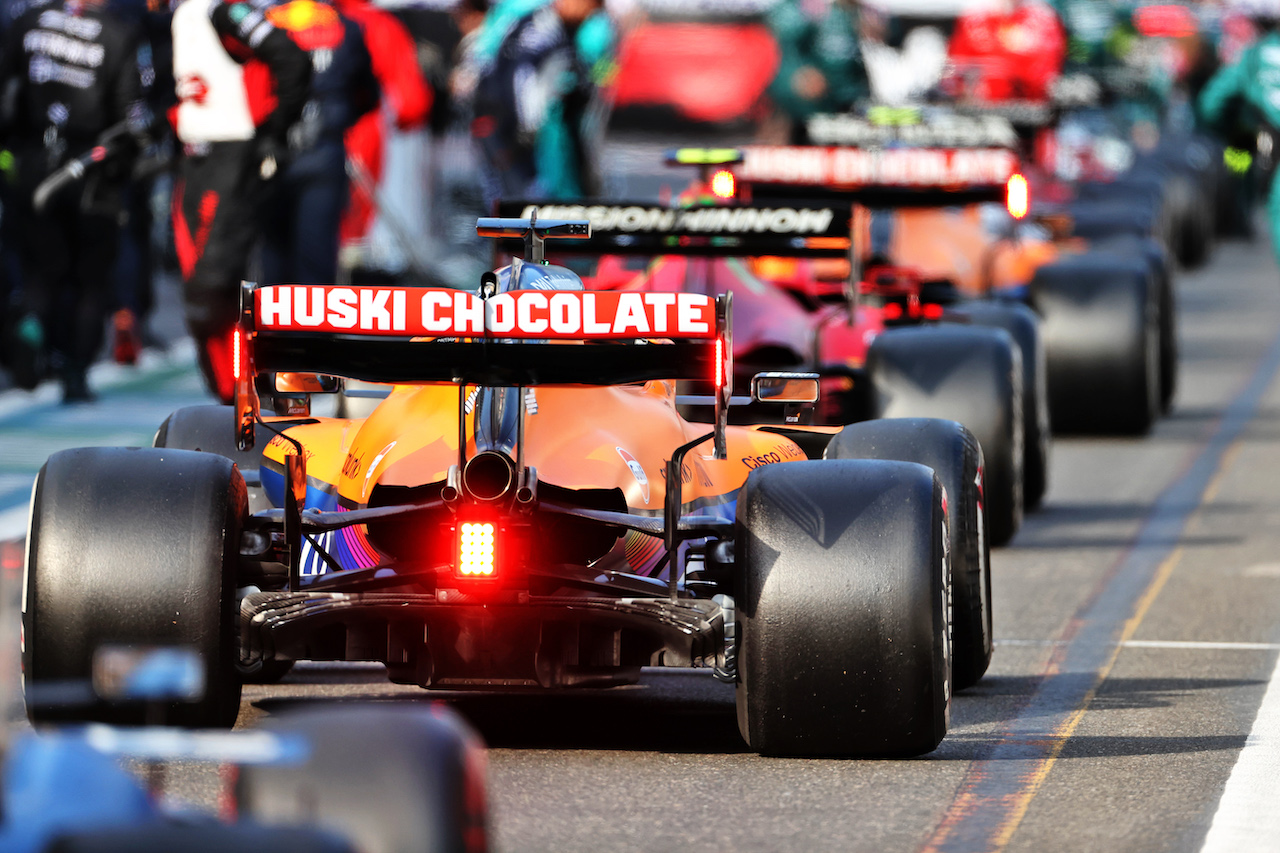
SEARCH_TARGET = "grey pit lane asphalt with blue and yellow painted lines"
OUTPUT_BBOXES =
[0,233,1280,850]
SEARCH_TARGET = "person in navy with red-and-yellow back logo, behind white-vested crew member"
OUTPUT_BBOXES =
[261,0,379,284]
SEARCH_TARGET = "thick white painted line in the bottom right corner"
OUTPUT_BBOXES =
[1201,648,1280,853]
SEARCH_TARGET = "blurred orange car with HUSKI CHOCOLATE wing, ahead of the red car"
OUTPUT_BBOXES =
[731,109,1178,434]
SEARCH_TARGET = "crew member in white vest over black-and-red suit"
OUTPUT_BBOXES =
[172,0,311,402]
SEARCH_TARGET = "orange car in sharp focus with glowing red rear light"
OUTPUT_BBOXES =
[23,219,992,756]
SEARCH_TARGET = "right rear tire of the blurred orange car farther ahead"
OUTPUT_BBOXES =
[1030,251,1164,435]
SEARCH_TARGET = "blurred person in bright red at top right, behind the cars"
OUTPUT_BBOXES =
[945,0,1066,101]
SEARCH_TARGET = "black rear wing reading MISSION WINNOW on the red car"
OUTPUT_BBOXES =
[498,199,852,257]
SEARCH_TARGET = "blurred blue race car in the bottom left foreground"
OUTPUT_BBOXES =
[0,617,488,853]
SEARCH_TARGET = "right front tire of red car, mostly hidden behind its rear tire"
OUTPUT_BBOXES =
[952,300,1052,511]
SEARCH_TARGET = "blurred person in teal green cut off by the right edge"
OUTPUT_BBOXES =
[1196,0,1280,257]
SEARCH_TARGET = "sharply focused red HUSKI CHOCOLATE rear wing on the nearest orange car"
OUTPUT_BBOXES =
[241,284,728,386]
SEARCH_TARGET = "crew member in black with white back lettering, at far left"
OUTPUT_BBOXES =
[0,0,150,402]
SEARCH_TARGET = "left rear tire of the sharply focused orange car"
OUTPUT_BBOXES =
[23,447,247,727]
